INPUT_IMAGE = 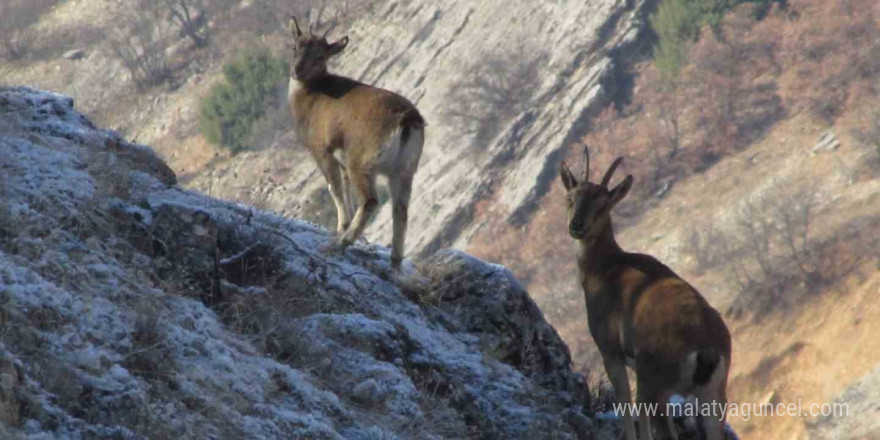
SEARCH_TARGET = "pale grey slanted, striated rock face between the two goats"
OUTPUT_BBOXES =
[352,0,645,253]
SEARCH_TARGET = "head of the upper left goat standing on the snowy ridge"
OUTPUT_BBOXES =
[290,17,348,82]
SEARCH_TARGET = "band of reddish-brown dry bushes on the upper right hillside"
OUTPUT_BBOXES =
[585,0,880,204]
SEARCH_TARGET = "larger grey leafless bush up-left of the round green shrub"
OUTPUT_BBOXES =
[107,1,171,87]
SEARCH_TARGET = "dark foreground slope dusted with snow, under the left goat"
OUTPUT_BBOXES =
[0,88,616,439]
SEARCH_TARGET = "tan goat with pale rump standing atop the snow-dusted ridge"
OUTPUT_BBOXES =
[288,17,425,269]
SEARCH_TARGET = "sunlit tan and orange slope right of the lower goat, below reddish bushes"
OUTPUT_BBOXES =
[620,116,880,439]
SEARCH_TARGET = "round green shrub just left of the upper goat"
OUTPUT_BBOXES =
[200,49,287,153]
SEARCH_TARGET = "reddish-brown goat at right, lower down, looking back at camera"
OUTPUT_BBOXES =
[560,149,730,440]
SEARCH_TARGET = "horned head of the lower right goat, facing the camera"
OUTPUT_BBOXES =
[559,148,633,244]
